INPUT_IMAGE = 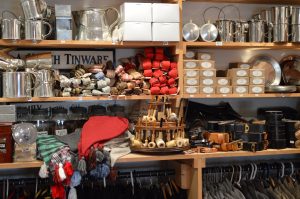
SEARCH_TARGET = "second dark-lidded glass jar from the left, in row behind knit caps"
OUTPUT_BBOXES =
[51,107,72,136]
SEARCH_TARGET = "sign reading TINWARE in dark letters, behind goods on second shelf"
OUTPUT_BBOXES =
[10,50,115,69]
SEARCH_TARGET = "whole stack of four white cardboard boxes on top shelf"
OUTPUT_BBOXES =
[119,2,180,41]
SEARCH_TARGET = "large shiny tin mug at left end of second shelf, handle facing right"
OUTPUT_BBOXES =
[2,72,40,98]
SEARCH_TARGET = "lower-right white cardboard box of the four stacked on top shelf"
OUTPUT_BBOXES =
[152,23,180,41]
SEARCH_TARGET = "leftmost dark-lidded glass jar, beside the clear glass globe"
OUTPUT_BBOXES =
[31,108,51,135]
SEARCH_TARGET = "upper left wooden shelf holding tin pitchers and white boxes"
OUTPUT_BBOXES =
[0,39,179,48]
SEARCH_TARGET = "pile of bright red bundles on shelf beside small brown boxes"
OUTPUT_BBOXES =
[142,48,178,95]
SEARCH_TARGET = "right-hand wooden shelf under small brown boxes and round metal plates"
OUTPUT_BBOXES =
[183,93,300,99]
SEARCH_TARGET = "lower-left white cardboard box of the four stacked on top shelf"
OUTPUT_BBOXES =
[120,22,152,41]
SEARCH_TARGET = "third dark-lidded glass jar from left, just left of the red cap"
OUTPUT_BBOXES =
[69,106,88,132]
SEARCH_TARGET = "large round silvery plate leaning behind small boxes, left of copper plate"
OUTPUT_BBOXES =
[250,55,281,86]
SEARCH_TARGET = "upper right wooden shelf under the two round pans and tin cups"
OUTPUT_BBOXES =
[183,42,300,52]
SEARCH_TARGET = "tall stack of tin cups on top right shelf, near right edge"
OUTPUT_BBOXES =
[272,6,291,42]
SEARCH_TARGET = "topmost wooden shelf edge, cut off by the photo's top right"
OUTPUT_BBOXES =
[185,0,300,5]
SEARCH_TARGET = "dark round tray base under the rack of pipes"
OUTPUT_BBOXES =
[131,147,184,155]
